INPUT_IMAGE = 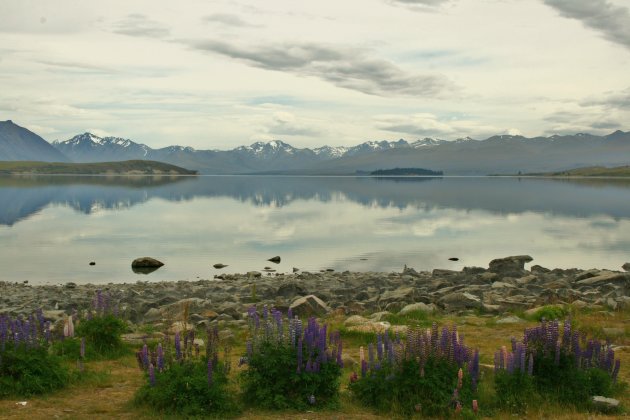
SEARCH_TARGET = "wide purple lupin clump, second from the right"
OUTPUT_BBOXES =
[350,323,479,417]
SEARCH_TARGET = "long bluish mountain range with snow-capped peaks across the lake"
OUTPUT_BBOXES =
[0,121,630,175]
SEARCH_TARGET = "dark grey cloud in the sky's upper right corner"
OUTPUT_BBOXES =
[543,0,630,48]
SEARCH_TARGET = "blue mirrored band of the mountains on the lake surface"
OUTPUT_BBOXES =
[0,176,630,226]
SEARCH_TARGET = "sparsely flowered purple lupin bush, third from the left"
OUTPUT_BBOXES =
[135,324,238,418]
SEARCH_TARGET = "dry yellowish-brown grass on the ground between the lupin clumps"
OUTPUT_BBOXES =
[0,308,630,420]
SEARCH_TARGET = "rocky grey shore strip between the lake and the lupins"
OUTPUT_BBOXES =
[0,255,630,325]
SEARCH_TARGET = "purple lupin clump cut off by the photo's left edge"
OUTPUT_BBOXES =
[0,311,71,396]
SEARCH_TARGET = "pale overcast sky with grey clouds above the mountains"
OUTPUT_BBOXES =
[0,0,630,150]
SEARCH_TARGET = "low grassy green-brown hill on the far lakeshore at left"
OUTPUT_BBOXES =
[0,160,197,175]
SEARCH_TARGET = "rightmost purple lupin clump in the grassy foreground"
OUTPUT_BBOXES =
[494,319,620,411]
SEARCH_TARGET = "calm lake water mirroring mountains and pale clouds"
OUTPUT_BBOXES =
[0,176,630,284]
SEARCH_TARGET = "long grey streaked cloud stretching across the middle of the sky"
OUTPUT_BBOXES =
[190,40,455,97]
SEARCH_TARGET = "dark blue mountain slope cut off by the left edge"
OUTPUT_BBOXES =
[0,120,69,162]
